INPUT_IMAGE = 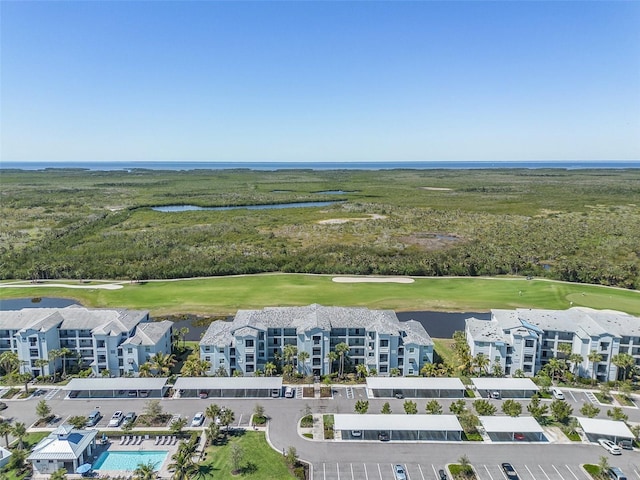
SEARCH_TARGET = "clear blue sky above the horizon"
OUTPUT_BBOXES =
[0,0,640,162]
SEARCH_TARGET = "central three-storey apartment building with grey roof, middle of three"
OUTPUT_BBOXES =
[200,304,433,376]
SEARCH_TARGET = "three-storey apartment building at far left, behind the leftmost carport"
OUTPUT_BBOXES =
[0,305,173,376]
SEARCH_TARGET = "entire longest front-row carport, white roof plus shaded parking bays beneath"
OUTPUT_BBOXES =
[333,414,462,441]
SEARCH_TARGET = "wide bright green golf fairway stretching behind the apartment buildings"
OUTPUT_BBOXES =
[0,274,640,315]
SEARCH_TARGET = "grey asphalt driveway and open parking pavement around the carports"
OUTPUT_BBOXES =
[1,388,640,480]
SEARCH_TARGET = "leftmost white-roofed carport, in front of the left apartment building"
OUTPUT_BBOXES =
[62,377,167,397]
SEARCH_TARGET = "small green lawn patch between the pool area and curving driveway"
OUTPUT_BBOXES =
[203,431,295,480]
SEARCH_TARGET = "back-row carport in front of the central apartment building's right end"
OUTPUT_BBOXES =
[367,377,465,398]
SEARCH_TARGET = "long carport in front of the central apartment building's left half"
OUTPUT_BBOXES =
[173,377,282,397]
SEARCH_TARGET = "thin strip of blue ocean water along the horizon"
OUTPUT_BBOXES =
[0,160,640,171]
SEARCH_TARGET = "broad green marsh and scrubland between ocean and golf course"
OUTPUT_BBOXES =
[0,169,640,288]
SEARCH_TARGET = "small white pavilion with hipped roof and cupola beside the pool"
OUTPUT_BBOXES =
[27,425,98,474]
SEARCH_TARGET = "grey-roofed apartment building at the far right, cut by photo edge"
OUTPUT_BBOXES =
[465,307,640,381]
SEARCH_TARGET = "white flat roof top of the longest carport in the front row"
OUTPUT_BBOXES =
[333,413,462,432]
